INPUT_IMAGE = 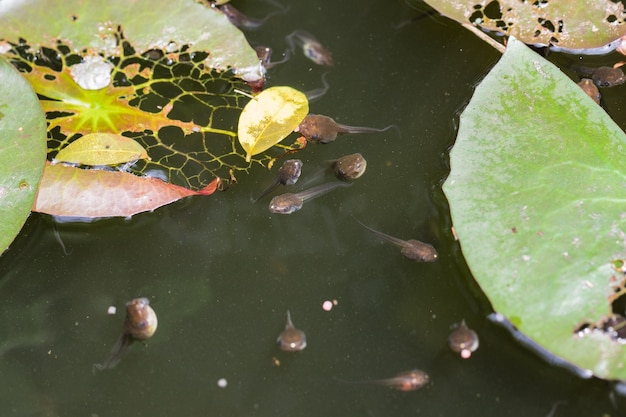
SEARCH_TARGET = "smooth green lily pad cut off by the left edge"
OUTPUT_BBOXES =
[0,54,46,250]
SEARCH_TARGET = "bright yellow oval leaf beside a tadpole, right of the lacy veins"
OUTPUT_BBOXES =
[237,87,309,162]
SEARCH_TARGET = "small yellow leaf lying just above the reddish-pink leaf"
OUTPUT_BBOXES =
[54,133,149,165]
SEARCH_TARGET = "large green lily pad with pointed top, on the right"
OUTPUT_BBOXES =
[444,38,626,379]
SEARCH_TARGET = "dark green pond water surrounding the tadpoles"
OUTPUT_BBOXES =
[0,0,624,417]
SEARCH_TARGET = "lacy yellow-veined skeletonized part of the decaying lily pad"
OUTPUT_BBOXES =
[5,28,304,190]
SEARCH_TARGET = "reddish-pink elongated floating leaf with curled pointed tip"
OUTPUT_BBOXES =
[33,165,219,219]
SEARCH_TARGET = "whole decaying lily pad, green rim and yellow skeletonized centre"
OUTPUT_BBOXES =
[0,0,299,205]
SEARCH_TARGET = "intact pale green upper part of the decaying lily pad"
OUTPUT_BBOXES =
[0,0,264,82]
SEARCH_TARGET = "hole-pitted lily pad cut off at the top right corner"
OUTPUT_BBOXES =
[425,0,626,49]
